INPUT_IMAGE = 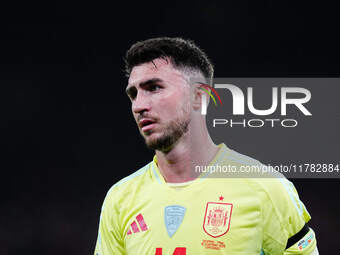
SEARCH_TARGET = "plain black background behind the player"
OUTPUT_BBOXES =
[0,1,340,255]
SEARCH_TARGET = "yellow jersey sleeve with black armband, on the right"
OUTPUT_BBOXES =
[262,178,315,255]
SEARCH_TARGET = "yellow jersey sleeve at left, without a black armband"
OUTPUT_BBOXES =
[94,189,126,255]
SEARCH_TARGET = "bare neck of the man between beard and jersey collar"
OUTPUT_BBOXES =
[156,120,218,183]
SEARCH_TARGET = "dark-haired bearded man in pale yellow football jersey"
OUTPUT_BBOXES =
[95,38,318,255]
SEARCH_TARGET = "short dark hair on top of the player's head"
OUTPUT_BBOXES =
[125,37,214,80]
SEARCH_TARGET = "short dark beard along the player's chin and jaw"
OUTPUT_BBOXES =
[145,116,190,152]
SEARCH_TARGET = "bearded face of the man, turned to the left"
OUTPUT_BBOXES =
[126,59,190,151]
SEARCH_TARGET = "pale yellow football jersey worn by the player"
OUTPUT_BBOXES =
[94,144,316,255]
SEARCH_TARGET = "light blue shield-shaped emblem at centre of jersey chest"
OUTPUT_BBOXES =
[164,205,186,237]
